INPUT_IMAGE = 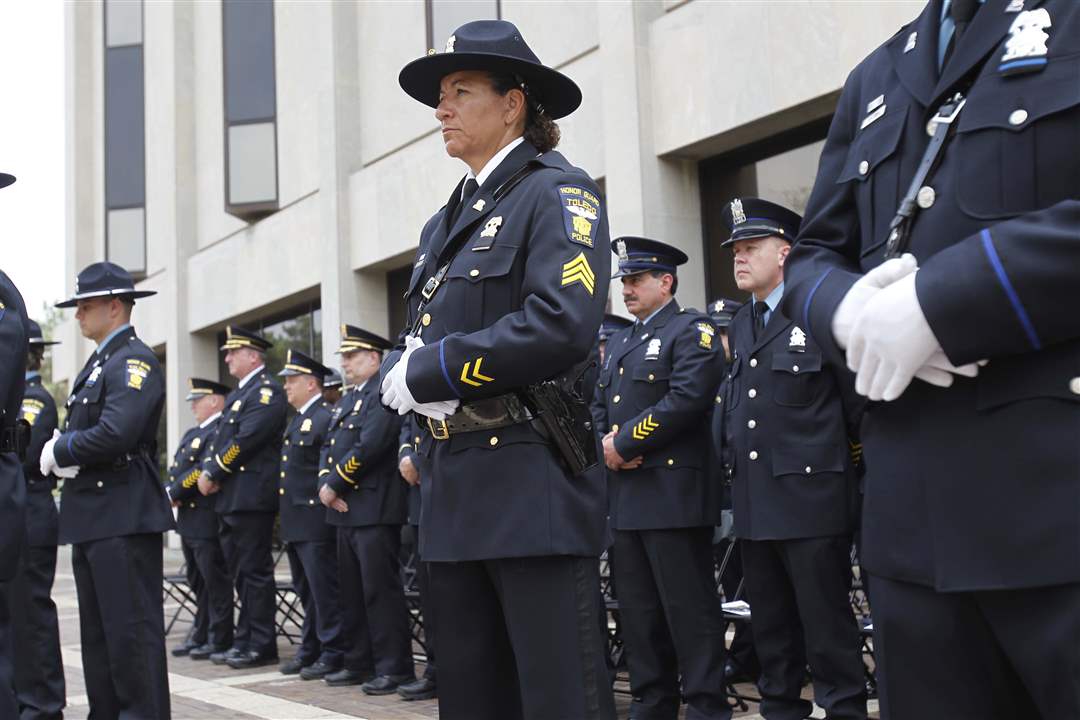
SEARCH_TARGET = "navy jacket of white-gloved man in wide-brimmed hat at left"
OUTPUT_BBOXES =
[53,327,173,543]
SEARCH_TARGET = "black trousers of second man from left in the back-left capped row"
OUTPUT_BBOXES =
[219,513,278,655]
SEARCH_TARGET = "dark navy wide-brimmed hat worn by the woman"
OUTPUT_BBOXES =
[397,21,581,120]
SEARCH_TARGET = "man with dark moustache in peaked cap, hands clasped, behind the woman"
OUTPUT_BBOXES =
[594,237,731,720]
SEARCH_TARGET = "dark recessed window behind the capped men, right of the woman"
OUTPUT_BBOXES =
[700,118,832,302]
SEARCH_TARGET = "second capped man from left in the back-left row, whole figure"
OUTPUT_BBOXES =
[199,325,286,669]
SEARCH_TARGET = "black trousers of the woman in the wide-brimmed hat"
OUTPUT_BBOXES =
[430,556,616,720]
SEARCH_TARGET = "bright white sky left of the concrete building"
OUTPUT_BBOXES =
[0,0,65,317]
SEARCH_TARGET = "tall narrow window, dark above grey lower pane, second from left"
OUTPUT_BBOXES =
[221,0,278,221]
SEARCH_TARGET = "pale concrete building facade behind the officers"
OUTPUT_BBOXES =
[54,0,922,459]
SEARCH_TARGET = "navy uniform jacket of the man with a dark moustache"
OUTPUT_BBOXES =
[593,300,723,530]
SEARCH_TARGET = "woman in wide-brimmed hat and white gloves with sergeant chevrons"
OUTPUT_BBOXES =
[382,21,615,720]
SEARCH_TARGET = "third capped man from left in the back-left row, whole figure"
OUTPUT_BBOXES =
[278,350,345,680]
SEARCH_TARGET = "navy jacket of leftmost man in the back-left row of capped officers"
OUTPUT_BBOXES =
[168,417,221,540]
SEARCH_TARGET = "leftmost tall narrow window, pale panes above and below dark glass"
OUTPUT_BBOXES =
[104,0,146,279]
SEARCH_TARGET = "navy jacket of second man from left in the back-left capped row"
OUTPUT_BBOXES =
[203,368,287,515]
